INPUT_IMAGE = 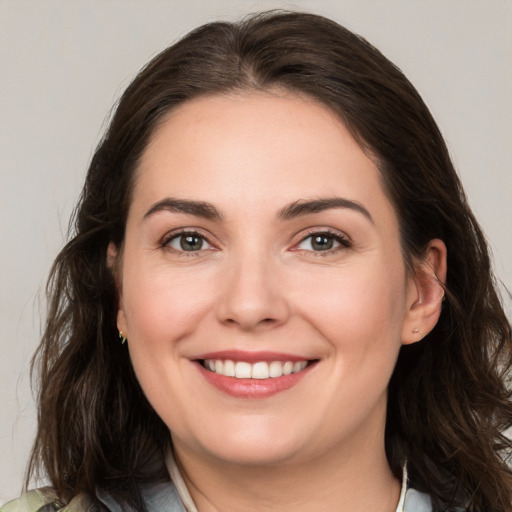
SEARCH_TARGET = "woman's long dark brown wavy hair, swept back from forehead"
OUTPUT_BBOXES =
[27,11,512,512]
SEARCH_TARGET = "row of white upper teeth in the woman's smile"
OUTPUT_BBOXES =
[204,359,308,379]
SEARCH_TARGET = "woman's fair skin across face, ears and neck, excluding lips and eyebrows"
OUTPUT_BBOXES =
[114,92,446,512]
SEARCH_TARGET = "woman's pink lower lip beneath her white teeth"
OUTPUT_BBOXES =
[196,361,316,399]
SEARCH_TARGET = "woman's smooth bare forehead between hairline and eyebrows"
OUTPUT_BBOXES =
[134,92,396,226]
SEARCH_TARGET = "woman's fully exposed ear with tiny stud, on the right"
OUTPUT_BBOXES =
[402,238,447,345]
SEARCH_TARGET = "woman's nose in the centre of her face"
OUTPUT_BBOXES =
[217,252,290,331]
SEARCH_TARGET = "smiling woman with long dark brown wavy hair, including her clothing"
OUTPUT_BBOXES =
[4,12,512,512]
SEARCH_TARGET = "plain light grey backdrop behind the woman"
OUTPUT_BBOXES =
[0,0,512,502]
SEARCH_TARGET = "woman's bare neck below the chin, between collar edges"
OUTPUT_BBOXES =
[175,434,400,512]
